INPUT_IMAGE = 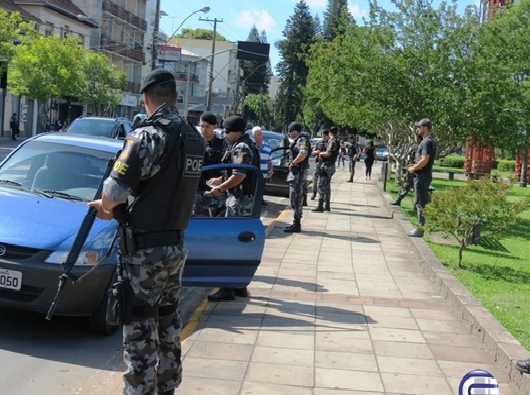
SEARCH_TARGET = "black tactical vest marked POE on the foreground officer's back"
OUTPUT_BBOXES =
[120,111,205,231]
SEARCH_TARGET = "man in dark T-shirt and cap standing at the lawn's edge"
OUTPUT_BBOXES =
[407,118,436,237]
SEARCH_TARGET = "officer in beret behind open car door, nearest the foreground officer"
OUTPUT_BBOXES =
[193,112,227,217]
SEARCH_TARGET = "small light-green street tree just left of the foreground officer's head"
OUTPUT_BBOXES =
[76,51,126,116]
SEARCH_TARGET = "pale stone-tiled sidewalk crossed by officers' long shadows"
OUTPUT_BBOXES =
[177,166,530,395]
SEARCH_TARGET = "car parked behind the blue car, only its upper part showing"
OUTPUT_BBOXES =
[66,117,132,139]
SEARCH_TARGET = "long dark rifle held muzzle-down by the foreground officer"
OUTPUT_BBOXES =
[46,156,117,321]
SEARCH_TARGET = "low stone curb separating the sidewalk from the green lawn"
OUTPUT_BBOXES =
[378,184,530,395]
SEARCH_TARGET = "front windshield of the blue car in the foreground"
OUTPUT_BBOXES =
[0,140,113,201]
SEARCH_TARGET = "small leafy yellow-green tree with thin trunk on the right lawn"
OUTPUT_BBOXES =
[424,178,530,267]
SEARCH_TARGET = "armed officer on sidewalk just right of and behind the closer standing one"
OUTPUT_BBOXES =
[311,126,340,213]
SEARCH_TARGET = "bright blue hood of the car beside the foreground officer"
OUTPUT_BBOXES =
[0,188,109,250]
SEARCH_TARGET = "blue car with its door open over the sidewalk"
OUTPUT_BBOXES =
[0,133,265,334]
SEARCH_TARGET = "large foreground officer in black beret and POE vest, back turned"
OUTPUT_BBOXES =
[88,69,205,395]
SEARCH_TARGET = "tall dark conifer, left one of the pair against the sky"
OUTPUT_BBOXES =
[275,0,317,130]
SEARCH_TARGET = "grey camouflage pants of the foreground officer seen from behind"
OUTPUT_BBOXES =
[121,245,188,395]
